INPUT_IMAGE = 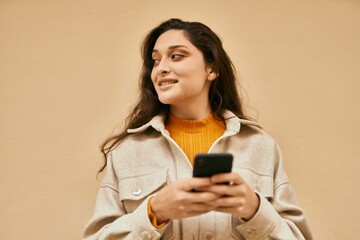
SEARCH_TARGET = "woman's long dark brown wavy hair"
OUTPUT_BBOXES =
[99,18,248,172]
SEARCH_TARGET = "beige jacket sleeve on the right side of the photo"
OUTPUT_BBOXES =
[237,144,313,240]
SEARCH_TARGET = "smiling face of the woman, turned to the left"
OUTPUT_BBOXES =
[151,30,216,115]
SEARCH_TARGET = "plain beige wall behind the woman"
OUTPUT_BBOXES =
[0,0,360,240]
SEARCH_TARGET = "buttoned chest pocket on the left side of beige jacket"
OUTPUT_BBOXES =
[119,169,167,213]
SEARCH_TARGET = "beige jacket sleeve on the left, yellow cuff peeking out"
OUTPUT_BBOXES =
[83,154,168,240]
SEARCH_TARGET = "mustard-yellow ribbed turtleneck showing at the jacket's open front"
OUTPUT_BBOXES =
[165,114,225,165]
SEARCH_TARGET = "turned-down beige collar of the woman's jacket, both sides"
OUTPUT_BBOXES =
[127,110,263,133]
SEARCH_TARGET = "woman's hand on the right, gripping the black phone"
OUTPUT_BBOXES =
[201,173,260,220]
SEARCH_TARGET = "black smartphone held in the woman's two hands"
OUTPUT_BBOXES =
[193,153,233,177]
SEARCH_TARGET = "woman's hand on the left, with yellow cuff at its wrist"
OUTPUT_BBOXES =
[150,178,221,222]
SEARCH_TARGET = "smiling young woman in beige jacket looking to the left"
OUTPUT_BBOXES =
[84,19,312,240]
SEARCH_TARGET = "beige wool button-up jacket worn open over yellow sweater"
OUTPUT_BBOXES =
[84,112,312,240]
